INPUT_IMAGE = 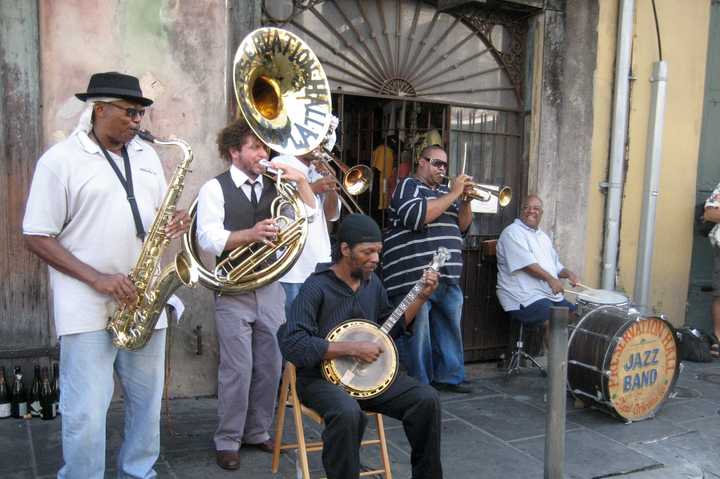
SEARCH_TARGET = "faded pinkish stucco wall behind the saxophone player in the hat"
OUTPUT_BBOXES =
[40,0,234,396]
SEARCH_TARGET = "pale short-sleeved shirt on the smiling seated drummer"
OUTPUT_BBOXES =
[497,219,564,311]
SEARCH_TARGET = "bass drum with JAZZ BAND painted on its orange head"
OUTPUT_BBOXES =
[568,306,679,422]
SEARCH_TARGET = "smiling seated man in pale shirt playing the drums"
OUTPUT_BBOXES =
[497,195,580,345]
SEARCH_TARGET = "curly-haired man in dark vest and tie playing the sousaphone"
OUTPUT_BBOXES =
[197,119,315,470]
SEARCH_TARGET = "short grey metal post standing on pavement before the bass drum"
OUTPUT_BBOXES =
[544,306,569,479]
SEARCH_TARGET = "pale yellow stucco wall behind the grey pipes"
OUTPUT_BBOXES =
[585,0,710,325]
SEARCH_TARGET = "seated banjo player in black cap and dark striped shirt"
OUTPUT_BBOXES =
[278,214,442,479]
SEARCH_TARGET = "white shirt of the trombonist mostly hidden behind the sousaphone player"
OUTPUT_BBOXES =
[273,155,340,283]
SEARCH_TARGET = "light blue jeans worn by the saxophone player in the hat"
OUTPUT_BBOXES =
[58,329,165,479]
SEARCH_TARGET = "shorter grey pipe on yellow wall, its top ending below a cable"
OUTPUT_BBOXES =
[633,61,667,311]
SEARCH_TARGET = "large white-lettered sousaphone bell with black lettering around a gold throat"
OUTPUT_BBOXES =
[233,27,332,156]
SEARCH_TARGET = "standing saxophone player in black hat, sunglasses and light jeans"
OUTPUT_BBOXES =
[23,72,190,479]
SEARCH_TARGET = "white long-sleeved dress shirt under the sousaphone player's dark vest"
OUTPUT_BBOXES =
[197,165,315,256]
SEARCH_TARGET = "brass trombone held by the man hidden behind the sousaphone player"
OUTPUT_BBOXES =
[310,147,373,214]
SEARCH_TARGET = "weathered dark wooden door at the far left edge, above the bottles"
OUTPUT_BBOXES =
[0,2,55,374]
